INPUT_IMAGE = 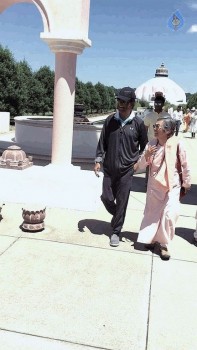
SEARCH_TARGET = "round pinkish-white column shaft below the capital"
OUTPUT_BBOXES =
[52,52,77,166]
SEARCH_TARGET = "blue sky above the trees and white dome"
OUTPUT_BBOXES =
[0,0,197,93]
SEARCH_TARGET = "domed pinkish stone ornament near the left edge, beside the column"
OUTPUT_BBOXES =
[0,145,33,170]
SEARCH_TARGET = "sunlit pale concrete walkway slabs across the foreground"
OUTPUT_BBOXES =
[0,134,197,350]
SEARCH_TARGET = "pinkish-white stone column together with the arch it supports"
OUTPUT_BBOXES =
[0,0,91,166]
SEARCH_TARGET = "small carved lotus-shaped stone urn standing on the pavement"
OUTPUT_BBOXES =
[21,208,46,232]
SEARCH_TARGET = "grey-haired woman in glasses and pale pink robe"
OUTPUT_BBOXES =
[135,117,191,260]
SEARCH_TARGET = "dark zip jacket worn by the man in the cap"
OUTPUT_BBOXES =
[95,114,148,177]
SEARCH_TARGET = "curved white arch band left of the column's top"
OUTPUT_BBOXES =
[0,0,50,33]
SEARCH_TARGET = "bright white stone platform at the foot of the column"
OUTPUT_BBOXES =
[0,164,102,211]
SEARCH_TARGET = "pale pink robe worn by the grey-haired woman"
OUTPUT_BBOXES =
[138,137,191,245]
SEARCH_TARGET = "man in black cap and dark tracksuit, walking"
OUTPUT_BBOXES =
[94,87,148,247]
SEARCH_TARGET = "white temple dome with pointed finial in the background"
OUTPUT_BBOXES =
[135,63,186,105]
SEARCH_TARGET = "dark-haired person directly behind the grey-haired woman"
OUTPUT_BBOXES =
[144,92,170,186]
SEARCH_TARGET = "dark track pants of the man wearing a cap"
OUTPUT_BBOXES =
[101,169,133,235]
